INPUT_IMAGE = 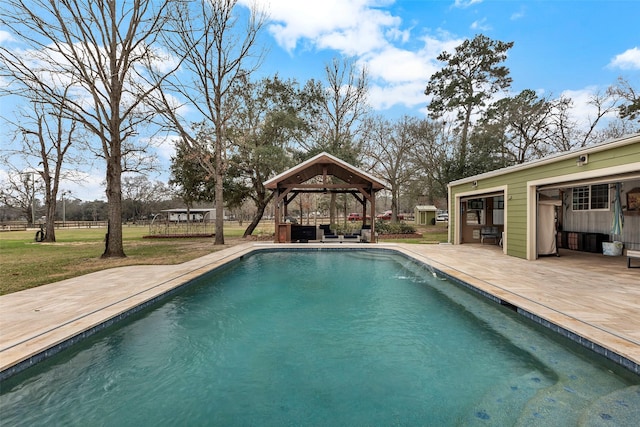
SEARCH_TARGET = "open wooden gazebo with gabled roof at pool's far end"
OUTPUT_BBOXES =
[264,152,387,243]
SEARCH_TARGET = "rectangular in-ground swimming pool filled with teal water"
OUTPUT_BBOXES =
[0,250,640,425]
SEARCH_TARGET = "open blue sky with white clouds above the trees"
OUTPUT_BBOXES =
[0,0,640,200]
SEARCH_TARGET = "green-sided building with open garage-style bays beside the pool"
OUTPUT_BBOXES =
[448,134,640,260]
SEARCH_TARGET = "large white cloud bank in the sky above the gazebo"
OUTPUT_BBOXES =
[241,0,464,113]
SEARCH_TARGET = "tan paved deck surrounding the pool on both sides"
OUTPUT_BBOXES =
[0,243,640,379]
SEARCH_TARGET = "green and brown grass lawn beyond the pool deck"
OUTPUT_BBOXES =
[0,224,446,295]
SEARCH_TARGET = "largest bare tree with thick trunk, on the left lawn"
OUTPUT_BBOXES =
[0,0,180,258]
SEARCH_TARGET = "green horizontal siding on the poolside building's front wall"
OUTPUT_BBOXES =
[449,140,640,258]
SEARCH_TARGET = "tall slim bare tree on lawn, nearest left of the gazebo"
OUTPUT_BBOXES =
[155,0,266,245]
